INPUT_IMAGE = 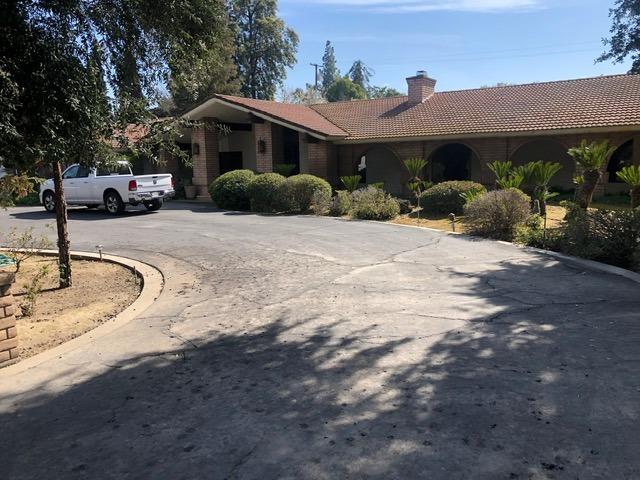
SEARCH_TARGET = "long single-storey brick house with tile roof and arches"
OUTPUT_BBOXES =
[169,71,640,196]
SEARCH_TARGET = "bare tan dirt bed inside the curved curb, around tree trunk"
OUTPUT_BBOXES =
[8,257,140,359]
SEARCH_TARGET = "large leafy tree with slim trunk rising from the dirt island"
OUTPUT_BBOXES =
[0,0,230,287]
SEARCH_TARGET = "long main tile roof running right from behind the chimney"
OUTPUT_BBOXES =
[310,75,640,140]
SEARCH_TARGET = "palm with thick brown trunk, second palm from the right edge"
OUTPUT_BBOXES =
[567,140,614,209]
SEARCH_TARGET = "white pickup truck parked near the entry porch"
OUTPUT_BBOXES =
[40,162,175,215]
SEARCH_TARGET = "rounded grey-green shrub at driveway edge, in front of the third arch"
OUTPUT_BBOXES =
[463,188,531,240]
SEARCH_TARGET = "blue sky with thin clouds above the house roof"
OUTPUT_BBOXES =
[280,0,629,92]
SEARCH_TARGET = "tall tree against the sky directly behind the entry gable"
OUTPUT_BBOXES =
[230,0,298,100]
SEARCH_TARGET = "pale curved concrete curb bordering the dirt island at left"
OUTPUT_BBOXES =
[0,248,164,378]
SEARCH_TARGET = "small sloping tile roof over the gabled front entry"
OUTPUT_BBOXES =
[216,95,347,137]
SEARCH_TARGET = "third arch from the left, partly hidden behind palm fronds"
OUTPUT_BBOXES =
[510,138,575,190]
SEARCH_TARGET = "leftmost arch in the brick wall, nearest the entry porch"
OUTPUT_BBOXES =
[357,146,403,195]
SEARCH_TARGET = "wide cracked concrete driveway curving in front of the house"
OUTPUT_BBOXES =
[0,203,640,480]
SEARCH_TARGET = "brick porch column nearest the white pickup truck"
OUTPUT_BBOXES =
[191,118,220,198]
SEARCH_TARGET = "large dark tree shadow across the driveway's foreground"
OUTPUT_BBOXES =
[0,256,640,480]
